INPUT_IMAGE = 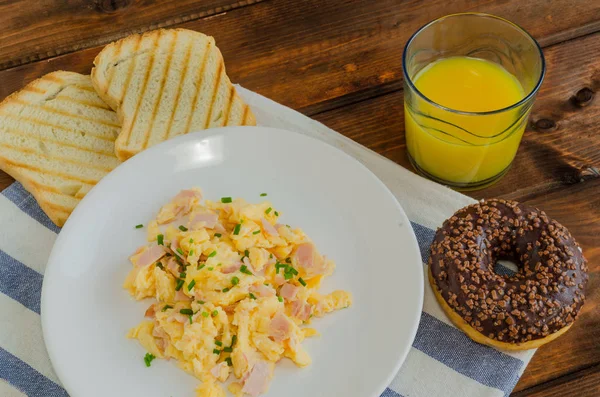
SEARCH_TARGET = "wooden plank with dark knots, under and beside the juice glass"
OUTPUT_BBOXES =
[314,33,600,200]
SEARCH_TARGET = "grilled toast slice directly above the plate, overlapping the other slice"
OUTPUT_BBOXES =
[92,29,256,161]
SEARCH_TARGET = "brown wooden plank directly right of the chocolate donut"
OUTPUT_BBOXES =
[516,179,600,390]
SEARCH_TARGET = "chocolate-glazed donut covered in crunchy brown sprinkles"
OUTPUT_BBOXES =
[429,200,588,350]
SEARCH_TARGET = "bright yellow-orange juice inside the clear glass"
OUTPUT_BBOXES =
[405,56,529,186]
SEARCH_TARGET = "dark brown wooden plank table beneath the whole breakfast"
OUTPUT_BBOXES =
[0,0,600,396]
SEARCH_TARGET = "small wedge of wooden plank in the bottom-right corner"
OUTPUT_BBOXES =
[511,365,600,397]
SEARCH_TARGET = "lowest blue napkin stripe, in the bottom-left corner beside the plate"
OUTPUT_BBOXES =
[0,347,69,397]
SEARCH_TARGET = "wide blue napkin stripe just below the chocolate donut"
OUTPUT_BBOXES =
[413,312,523,392]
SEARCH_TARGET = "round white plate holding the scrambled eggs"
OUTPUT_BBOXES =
[42,127,423,397]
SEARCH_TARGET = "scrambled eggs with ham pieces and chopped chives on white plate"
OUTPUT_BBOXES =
[124,189,352,397]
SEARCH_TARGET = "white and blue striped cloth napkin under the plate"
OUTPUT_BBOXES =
[0,87,534,397]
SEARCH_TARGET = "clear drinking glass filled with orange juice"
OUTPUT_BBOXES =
[403,13,545,190]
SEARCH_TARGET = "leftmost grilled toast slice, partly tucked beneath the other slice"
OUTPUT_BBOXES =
[0,71,121,226]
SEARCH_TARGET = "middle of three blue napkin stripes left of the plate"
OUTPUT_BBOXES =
[0,250,43,314]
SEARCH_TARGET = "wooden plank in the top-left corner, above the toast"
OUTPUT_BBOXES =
[0,0,262,69]
